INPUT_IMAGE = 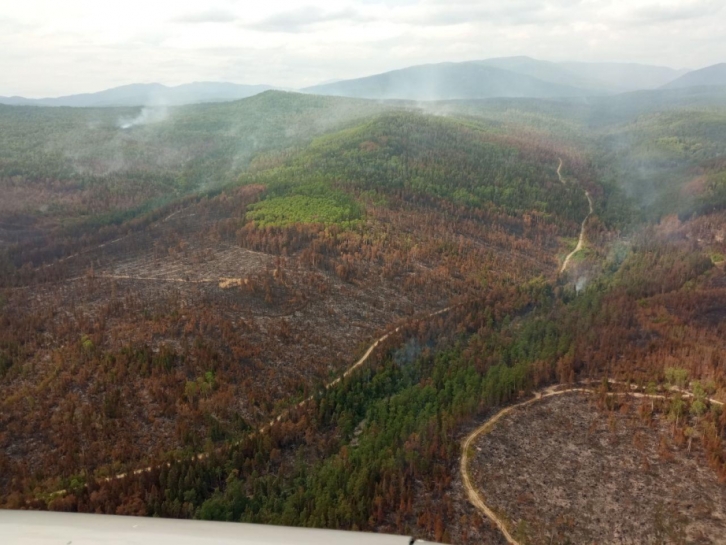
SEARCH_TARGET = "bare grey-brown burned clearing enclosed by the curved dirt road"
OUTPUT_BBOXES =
[470,393,726,544]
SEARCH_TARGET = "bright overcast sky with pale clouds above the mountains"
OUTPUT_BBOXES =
[0,0,726,98]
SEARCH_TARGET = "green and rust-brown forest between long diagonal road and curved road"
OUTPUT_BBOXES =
[6,206,726,543]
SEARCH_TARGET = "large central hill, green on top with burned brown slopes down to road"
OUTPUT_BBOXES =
[0,110,587,506]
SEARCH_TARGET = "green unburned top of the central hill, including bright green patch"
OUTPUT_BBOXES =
[242,112,587,229]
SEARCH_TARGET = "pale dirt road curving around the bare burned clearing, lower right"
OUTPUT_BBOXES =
[459,379,724,545]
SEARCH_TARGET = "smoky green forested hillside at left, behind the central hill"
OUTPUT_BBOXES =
[0,91,387,255]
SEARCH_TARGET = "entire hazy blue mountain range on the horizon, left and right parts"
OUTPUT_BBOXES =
[0,56,726,107]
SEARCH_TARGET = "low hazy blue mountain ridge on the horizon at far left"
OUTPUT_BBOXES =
[0,82,274,107]
